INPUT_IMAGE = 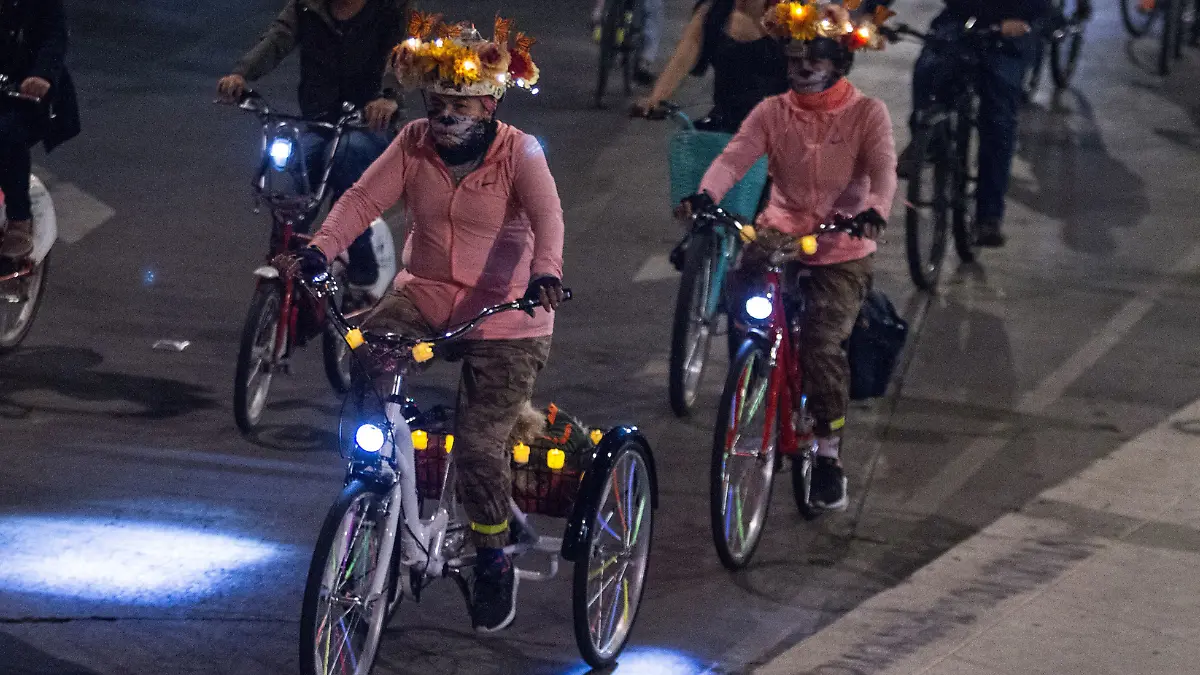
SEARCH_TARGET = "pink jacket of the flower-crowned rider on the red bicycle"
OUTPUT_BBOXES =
[700,79,896,265]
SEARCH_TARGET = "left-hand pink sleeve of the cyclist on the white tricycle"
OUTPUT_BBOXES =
[312,132,407,259]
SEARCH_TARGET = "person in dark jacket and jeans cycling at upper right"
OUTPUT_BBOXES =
[900,0,1050,246]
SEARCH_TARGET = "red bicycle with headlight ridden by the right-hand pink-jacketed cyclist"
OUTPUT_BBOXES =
[698,208,871,571]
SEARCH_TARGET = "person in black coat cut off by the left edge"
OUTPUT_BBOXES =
[0,0,79,258]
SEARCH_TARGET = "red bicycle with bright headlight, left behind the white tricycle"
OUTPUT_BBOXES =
[223,90,395,434]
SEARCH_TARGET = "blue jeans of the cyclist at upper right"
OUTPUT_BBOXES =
[912,13,1036,222]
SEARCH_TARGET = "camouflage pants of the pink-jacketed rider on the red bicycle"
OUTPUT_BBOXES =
[798,258,871,436]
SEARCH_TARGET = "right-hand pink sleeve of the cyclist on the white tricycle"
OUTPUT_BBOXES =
[512,136,564,279]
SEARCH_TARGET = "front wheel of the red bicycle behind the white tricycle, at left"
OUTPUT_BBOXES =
[233,282,283,434]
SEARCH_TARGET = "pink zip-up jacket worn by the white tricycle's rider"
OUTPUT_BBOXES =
[312,119,563,340]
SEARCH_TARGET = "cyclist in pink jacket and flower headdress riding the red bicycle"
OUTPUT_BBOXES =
[682,0,896,509]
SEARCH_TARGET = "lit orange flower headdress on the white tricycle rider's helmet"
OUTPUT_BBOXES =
[391,12,541,98]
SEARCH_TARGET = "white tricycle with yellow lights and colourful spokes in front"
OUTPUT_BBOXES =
[300,274,658,675]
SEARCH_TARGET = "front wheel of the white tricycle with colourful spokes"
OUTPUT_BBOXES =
[310,490,388,675]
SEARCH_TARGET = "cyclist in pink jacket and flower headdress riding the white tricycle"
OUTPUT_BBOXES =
[290,14,563,632]
